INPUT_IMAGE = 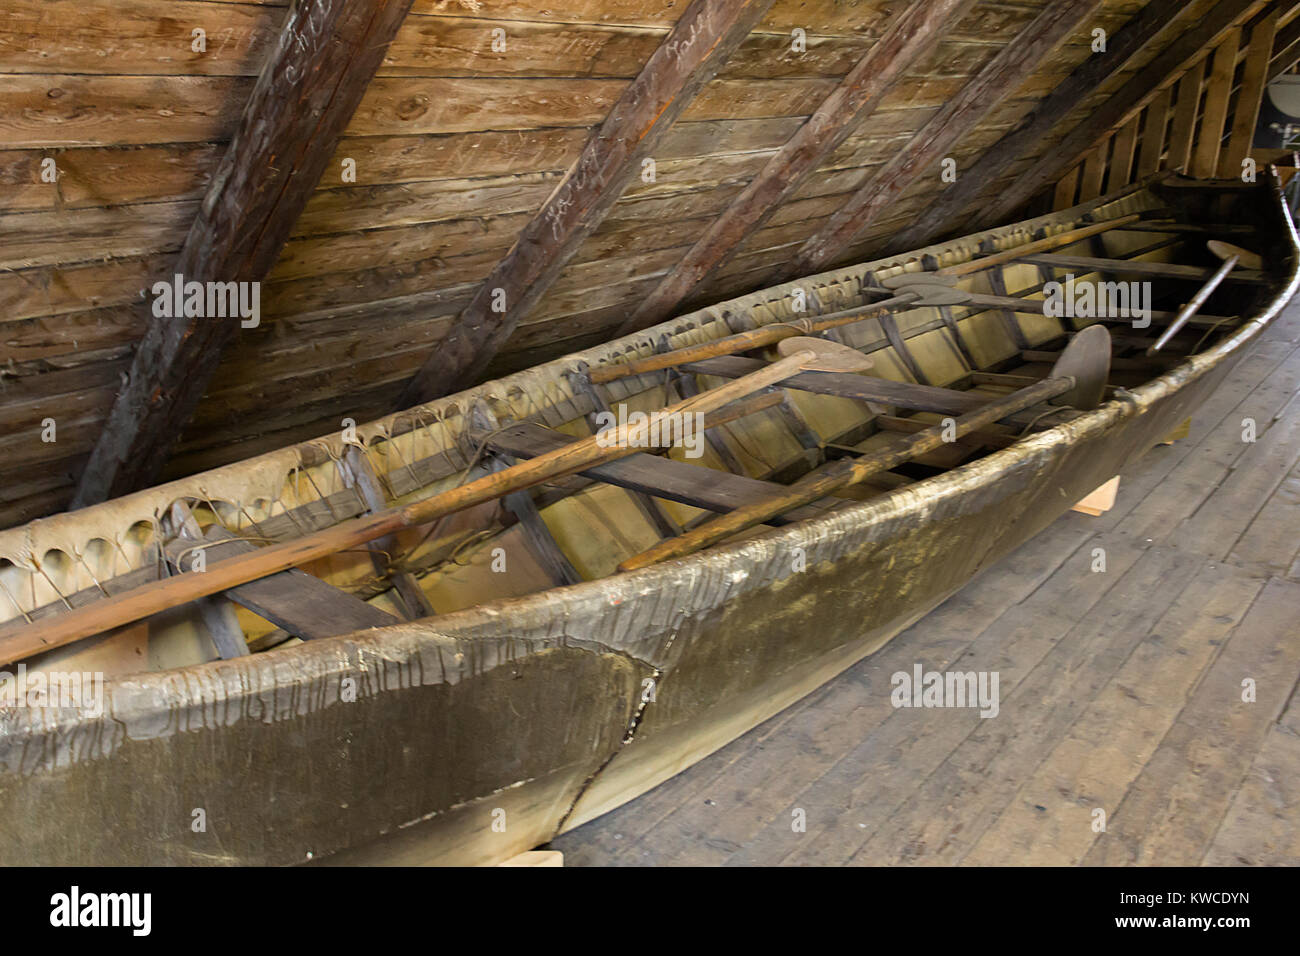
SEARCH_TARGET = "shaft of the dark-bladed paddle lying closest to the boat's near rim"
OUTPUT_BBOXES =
[619,378,1074,571]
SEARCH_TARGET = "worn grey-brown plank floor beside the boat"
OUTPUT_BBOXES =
[551,293,1300,866]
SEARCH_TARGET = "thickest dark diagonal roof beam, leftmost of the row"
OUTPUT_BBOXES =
[72,0,412,507]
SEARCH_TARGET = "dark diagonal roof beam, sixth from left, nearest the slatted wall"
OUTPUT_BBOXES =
[980,0,1265,230]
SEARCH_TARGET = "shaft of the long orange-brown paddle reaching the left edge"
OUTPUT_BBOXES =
[0,351,816,662]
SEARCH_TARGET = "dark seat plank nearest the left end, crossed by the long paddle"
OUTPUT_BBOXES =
[166,527,399,641]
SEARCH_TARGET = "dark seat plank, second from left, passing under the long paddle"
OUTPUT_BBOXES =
[488,423,823,524]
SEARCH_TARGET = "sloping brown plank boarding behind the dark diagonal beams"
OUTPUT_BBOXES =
[0,0,1237,527]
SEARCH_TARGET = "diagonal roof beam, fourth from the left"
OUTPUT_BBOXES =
[781,0,1100,277]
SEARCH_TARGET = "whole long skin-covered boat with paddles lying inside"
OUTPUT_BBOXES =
[0,177,1300,864]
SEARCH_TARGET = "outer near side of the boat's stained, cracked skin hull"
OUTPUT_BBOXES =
[0,180,1296,865]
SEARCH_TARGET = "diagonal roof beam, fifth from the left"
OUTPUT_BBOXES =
[887,0,1186,254]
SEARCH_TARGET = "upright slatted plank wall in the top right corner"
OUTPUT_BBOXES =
[1052,7,1300,209]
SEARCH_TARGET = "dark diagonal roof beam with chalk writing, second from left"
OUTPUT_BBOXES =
[399,0,774,407]
